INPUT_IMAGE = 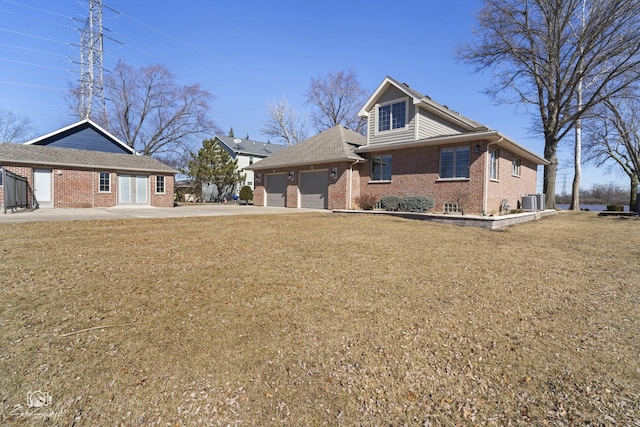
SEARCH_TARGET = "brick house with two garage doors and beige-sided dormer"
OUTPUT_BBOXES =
[247,77,547,215]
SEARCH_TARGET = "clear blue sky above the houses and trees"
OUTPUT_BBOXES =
[0,0,628,193]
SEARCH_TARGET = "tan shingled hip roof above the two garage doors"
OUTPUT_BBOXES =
[245,126,367,170]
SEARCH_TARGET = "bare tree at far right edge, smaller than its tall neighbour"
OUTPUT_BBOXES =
[585,93,640,210]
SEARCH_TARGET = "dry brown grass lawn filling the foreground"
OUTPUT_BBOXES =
[0,213,640,426]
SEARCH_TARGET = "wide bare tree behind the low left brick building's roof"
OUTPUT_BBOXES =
[68,61,215,156]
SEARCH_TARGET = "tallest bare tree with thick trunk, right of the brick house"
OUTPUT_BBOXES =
[458,0,640,208]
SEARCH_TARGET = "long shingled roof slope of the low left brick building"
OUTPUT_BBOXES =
[0,142,177,174]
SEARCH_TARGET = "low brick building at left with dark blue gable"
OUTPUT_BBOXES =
[0,120,177,208]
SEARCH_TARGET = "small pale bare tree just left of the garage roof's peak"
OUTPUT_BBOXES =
[261,97,307,145]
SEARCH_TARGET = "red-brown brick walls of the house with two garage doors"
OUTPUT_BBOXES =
[253,141,537,215]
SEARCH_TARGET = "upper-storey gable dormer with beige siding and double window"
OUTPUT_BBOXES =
[358,77,486,145]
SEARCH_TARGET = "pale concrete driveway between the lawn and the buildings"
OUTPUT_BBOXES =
[0,204,331,224]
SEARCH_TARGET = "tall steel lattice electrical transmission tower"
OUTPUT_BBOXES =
[80,0,107,124]
